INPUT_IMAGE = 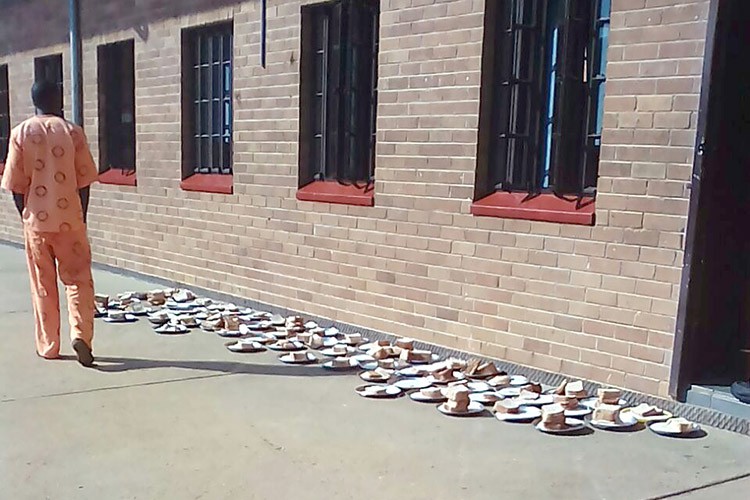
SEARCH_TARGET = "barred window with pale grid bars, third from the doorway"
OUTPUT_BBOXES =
[182,22,233,182]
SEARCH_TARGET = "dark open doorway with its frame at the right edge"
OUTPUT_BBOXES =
[671,0,750,399]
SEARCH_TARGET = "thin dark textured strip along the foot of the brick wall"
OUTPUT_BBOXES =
[0,240,750,436]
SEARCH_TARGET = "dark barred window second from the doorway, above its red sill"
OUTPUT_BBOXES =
[300,0,380,199]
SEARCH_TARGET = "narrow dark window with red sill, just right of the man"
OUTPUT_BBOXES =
[97,40,135,184]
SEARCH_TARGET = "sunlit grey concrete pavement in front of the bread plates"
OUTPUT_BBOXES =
[0,246,750,500]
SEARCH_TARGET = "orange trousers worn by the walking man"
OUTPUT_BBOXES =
[24,228,95,358]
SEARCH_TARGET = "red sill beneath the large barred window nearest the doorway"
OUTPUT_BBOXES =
[471,192,595,226]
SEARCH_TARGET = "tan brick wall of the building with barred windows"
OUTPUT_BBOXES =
[0,0,709,395]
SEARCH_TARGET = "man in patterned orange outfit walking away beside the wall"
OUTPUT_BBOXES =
[2,81,98,366]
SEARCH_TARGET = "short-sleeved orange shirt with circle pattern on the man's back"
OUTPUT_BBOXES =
[2,115,98,233]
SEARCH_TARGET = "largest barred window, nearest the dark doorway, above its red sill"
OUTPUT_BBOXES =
[476,0,611,222]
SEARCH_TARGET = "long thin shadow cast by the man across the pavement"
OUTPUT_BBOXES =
[94,357,352,377]
